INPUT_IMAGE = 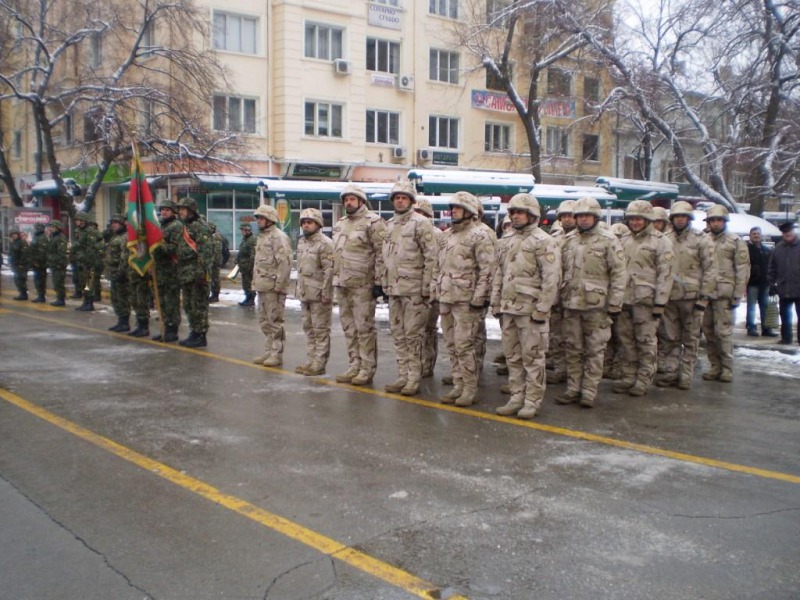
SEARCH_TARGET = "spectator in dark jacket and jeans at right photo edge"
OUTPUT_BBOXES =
[767,222,800,344]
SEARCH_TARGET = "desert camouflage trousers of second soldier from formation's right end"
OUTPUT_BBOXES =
[659,300,703,380]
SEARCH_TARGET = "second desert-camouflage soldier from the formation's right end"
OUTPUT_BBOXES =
[656,202,717,390]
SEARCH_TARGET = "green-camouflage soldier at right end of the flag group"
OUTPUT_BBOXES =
[178,196,213,348]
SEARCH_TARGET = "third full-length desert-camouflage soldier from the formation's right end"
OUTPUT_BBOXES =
[612,200,675,396]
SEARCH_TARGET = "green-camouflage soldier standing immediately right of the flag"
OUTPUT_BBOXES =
[153,200,183,342]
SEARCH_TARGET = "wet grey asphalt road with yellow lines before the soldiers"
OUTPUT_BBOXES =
[0,278,800,600]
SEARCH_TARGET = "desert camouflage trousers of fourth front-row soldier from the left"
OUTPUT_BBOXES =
[389,296,430,383]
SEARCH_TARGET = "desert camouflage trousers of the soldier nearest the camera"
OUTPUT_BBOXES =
[502,313,550,408]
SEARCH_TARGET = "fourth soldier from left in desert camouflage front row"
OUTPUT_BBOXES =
[382,181,436,396]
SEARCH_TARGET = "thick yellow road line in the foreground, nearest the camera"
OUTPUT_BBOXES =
[0,388,465,600]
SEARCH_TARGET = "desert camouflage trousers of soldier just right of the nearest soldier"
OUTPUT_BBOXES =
[563,309,611,401]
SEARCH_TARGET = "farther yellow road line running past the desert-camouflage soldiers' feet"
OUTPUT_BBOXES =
[3,313,800,483]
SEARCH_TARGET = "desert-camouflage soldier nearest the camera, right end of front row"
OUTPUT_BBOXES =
[492,194,561,419]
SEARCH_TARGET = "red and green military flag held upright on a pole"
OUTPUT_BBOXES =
[128,149,163,277]
